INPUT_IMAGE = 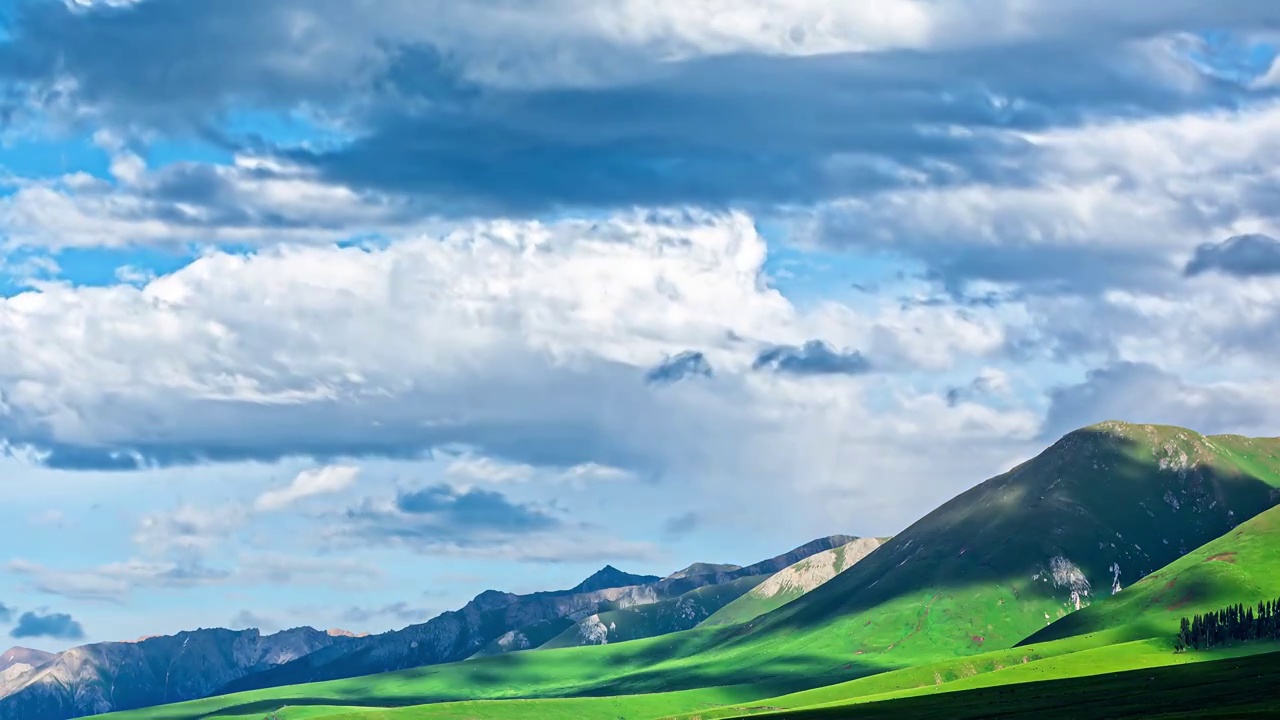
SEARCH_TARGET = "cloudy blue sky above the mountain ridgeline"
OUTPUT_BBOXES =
[0,0,1280,651]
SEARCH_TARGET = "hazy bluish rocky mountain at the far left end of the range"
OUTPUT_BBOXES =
[0,628,352,720]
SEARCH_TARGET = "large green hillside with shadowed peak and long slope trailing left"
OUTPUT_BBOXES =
[94,423,1280,717]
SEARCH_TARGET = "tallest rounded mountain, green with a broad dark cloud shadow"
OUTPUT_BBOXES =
[739,421,1280,665]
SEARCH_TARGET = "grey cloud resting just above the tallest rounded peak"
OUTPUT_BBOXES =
[1041,363,1268,439]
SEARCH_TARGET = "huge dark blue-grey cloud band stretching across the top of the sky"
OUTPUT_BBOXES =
[0,0,1276,212]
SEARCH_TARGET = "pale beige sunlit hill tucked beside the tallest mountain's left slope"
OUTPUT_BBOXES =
[703,538,888,625]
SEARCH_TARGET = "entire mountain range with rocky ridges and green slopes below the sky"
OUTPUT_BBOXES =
[0,421,1280,720]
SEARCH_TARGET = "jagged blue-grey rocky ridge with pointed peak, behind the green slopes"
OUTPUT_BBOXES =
[220,536,850,693]
